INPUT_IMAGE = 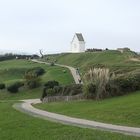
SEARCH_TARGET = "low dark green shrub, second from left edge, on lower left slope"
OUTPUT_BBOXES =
[7,82,24,93]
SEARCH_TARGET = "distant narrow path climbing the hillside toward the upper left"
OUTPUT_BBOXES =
[31,59,82,84]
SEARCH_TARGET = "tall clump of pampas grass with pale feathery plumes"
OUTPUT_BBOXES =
[83,68,114,100]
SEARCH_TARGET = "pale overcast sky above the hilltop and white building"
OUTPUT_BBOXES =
[0,0,140,53]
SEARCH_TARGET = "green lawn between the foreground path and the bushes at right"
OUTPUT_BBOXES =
[35,92,140,127]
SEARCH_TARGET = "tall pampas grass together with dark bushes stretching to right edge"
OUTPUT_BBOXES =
[83,69,140,100]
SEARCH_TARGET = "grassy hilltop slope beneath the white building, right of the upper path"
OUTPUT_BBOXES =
[45,50,140,73]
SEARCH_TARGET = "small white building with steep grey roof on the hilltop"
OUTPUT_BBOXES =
[71,33,85,53]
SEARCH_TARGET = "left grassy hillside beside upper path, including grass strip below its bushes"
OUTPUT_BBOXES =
[0,60,74,100]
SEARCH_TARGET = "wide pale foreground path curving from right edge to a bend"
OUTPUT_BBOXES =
[13,99,140,137]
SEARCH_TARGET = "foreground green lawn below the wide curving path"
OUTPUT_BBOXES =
[0,101,139,140]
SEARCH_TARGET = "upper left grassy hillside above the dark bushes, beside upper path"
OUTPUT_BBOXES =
[0,60,74,84]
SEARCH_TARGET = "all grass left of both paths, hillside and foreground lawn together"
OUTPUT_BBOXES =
[0,60,139,140]
